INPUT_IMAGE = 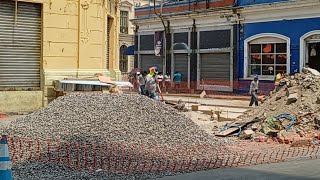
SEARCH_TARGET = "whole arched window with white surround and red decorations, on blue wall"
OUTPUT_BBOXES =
[244,34,290,78]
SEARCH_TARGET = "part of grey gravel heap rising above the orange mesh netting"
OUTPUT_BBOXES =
[3,93,215,144]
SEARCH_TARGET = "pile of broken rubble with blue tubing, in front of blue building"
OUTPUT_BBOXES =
[238,68,320,142]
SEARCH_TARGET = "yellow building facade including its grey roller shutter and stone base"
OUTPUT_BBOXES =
[0,0,121,112]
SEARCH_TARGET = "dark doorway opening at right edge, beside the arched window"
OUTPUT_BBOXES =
[308,42,320,71]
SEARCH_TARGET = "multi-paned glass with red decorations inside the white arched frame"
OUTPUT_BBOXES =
[249,43,288,76]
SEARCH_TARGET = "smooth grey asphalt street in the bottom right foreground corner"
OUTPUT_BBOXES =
[159,159,320,180]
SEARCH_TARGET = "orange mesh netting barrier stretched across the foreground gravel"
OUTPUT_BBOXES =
[8,136,320,173]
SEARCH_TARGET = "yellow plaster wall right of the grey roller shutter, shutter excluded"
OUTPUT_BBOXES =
[4,0,121,111]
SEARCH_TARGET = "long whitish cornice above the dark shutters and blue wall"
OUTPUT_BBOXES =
[132,0,320,29]
